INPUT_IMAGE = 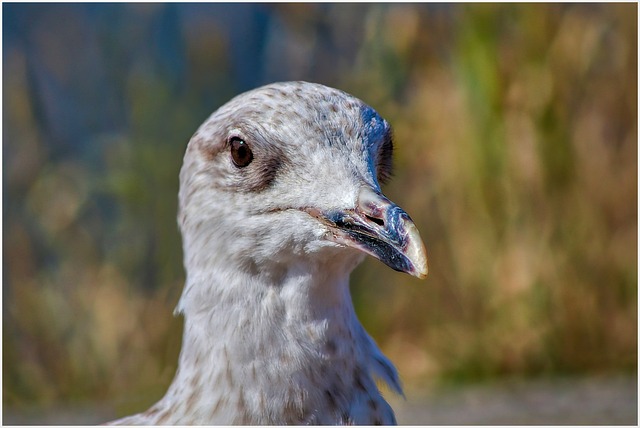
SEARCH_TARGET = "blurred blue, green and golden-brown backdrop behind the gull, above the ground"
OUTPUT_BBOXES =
[2,3,638,423]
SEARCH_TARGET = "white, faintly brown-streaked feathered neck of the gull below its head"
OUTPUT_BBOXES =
[152,249,381,424]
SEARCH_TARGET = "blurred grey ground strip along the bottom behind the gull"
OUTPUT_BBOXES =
[3,375,638,425]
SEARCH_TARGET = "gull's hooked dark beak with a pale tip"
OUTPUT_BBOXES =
[308,186,428,278]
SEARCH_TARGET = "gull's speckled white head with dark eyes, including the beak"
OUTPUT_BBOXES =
[179,82,427,278]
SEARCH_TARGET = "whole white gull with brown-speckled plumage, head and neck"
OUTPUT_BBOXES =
[111,82,427,425]
